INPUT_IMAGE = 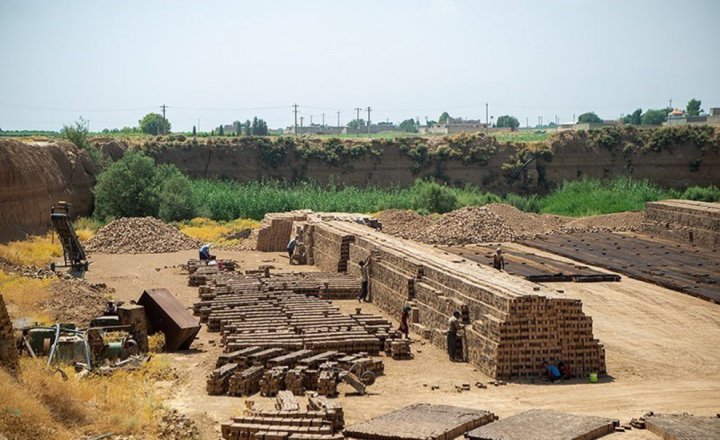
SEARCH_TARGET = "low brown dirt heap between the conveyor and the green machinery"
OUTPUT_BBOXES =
[46,278,114,327]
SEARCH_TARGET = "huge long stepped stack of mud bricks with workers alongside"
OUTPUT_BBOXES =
[301,221,606,378]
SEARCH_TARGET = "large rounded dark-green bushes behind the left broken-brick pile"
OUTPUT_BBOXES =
[93,152,194,220]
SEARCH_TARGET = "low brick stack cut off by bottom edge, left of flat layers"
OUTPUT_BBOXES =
[221,410,345,440]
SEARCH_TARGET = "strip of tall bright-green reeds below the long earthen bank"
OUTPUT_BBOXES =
[191,178,720,221]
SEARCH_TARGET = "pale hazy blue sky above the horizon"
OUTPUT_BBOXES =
[0,0,720,130]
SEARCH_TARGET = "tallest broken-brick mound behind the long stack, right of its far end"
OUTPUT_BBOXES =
[422,206,517,245]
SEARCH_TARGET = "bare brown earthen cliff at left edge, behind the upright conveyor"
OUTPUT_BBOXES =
[0,140,97,241]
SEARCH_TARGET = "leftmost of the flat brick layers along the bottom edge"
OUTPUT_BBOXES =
[343,403,495,440]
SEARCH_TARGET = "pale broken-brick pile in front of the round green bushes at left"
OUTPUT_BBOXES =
[85,217,202,254]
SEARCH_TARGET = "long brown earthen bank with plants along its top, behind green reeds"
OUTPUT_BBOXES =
[141,126,720,193]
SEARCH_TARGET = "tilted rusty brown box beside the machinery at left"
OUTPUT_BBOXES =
[137,289,200,351]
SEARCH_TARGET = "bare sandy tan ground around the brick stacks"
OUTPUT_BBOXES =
[86,244,720,439]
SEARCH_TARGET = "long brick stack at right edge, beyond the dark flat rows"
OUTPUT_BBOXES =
[641,200,720,248]
